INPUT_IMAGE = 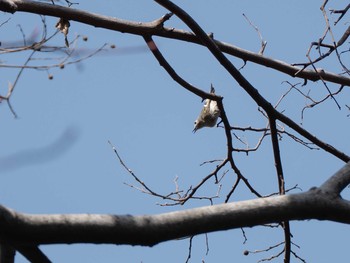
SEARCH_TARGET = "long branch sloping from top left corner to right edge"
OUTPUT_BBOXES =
[0,0,350,86]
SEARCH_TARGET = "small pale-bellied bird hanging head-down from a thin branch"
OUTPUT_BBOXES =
[192,85,220,133]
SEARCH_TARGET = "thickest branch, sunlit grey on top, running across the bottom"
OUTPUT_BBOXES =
[0,171,350,250]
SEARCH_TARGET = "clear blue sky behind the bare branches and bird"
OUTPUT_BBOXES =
[0,0,350,263]
